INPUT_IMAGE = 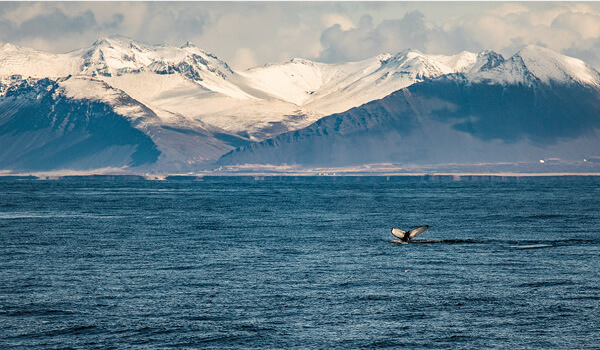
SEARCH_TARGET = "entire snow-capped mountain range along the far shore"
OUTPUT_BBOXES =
[0,37,600,172]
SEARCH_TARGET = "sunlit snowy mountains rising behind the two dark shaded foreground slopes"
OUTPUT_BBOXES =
[0,36,502,141]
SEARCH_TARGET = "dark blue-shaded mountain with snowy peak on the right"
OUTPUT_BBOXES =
[220,46,600,171]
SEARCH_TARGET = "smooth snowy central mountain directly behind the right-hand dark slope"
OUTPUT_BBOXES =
[242,50,502,115]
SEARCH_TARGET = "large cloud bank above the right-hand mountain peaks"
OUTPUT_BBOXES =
[320,3,600,67]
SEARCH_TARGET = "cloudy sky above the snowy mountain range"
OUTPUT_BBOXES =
[0,1,600,69]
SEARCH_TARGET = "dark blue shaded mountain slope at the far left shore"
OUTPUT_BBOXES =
[0,79,160,170]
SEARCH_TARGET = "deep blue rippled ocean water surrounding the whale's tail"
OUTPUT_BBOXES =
[0,177,600,349]
